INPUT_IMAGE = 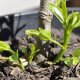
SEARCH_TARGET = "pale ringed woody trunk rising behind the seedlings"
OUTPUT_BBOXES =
[39,0,56,31]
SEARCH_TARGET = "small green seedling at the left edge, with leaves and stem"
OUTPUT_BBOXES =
[0,41,24,70]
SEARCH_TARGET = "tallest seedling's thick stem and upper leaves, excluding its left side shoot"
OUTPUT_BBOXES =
[49,0,80,63]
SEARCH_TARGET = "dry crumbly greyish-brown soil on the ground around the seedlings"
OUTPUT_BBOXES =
[0,28,80,80]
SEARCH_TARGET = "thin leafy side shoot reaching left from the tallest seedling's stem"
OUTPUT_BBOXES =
[25,28,64,48]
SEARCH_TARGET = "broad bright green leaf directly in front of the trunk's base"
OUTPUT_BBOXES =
[39,30,52,41]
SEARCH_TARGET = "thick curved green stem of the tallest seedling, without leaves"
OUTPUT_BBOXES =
[53,29,70,63]
